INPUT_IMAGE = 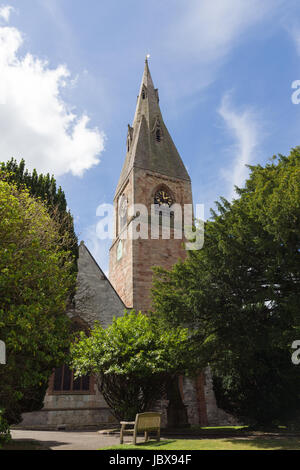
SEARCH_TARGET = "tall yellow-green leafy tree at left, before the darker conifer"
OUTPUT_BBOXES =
[0,180,75,423]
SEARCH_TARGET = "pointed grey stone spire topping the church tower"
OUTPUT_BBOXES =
[116,57,190,194]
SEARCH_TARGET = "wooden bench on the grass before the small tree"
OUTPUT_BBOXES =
[120,412,161,445]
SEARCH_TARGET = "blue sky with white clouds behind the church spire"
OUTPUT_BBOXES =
[0,0,300,271]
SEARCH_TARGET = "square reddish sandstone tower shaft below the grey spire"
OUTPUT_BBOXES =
[110,168,192,311]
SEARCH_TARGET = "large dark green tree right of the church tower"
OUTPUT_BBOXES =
[153,147,300,424]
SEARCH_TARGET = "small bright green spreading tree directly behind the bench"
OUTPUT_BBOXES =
[71,311,199,420]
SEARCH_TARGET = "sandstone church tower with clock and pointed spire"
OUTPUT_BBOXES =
[109,59,192,312]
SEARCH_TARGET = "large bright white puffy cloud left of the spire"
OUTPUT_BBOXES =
[0,17,105,176]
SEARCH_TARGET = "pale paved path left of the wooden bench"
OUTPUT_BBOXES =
[11,429,122,450]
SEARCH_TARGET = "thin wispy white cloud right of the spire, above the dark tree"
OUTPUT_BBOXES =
[219,94,261,199]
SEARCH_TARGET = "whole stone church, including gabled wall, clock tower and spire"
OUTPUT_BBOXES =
[21,59,234,429]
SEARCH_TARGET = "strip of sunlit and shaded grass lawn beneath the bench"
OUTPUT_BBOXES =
[99,437,300,450]
